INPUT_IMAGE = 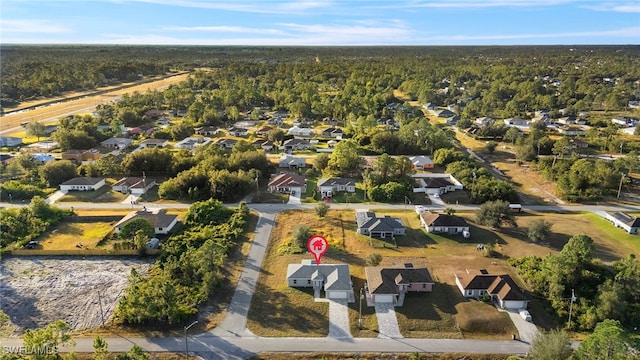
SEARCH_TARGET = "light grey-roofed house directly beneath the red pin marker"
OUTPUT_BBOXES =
[287,259,355,302]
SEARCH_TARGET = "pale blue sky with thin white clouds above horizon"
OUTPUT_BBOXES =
[0,0,640,46]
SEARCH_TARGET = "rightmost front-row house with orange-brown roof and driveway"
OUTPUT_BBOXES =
[454,269,529,310]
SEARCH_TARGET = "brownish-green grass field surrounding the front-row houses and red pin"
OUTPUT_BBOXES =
[248,210,640,339]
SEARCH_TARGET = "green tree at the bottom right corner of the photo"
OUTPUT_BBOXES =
[575,319,640,360]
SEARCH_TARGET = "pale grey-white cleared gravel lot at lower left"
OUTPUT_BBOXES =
[0,256,154,334]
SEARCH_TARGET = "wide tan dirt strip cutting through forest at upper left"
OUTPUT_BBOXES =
[0,74,189,131]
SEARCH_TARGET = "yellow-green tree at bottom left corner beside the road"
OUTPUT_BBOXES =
[23,320,73,360]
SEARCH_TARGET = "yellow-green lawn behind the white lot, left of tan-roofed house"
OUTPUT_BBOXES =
[40,222,113,250]
